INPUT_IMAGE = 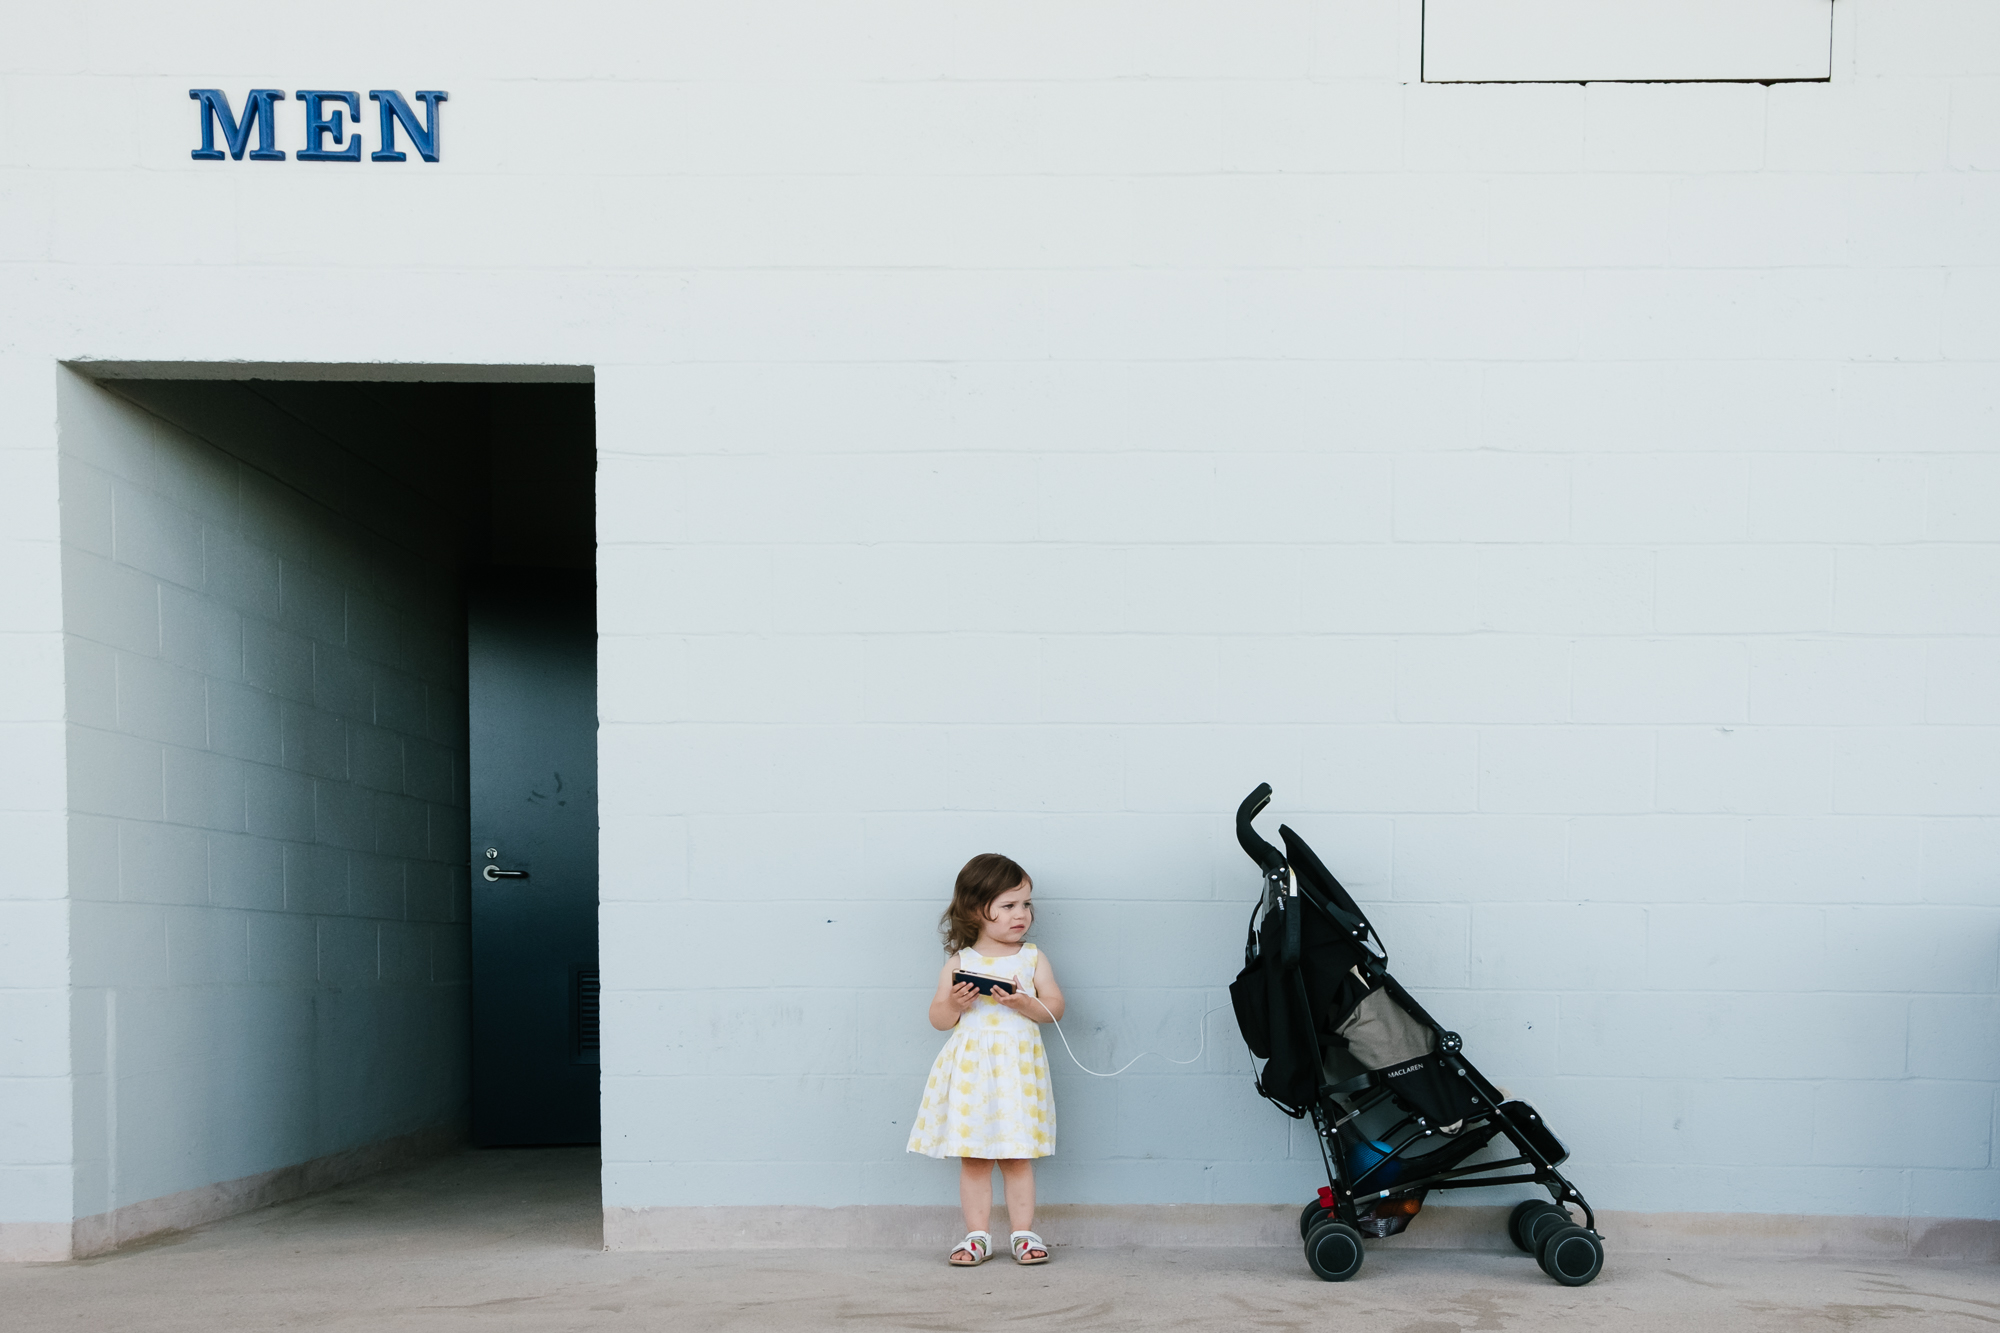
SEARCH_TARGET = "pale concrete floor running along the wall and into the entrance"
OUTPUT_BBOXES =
[0,1149,2000,1333]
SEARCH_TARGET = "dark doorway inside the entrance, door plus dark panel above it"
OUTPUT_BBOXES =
[466,384,598,1145]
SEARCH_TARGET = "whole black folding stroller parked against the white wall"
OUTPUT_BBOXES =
[1230,783,1604,1287]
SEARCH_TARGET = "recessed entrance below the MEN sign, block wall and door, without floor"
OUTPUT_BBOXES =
[60,364,598,1249]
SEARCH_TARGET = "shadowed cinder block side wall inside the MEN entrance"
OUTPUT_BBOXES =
[60,372,468,1249]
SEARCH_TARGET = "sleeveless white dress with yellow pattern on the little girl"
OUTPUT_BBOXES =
[910,945,1056,1159]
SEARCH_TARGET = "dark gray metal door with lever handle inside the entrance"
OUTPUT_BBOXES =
[466,570,598,1145]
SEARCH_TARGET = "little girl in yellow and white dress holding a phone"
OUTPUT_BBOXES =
[910,853,1062,1269]
